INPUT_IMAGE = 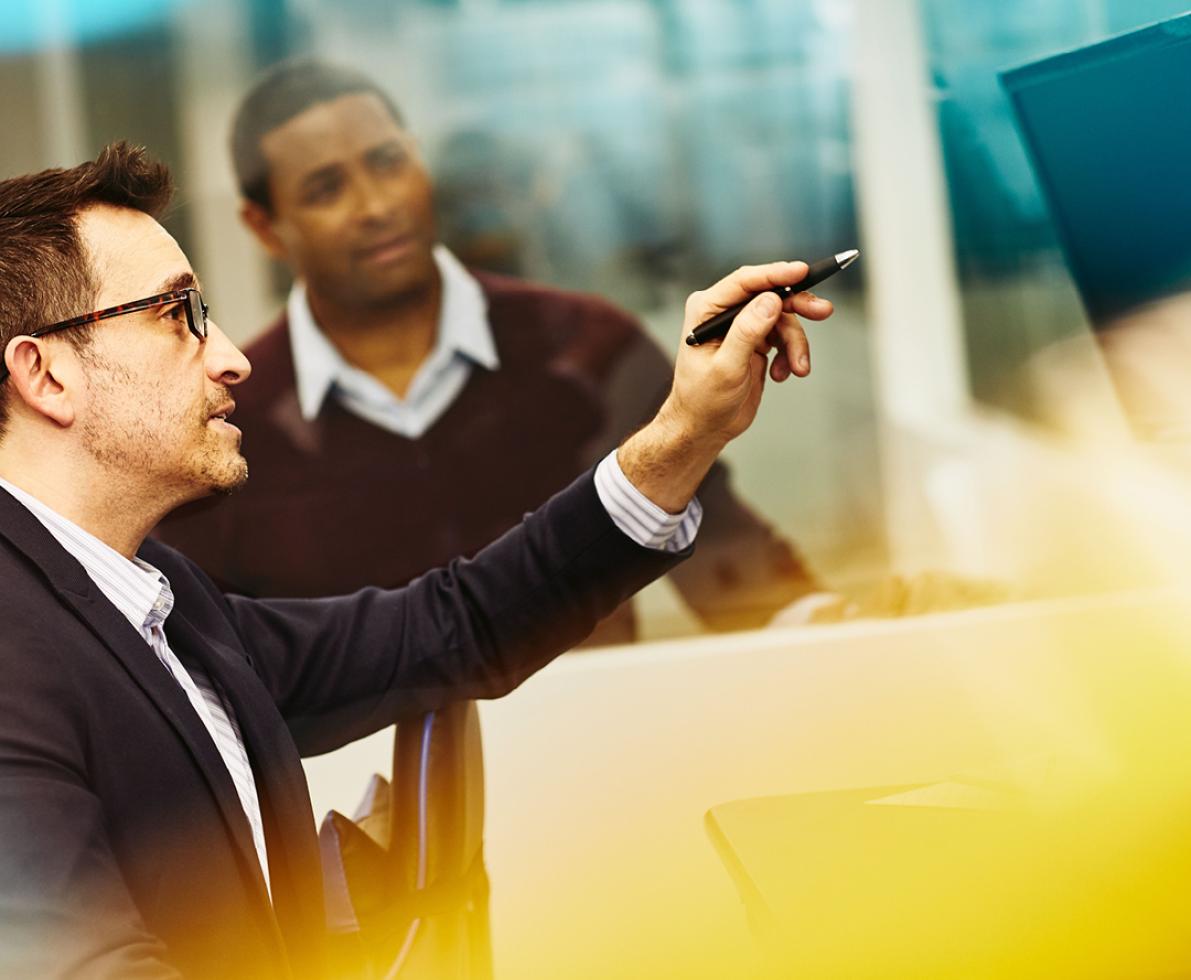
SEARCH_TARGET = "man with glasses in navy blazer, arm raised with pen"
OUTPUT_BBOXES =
[0,144,824,980]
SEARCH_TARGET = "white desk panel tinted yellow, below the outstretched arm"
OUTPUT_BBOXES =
[300,592,1191,980]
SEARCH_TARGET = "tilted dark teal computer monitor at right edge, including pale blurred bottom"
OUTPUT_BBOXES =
[1002,14,1191,447]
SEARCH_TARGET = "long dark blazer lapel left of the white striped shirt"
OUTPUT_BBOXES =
[0,489,268,905]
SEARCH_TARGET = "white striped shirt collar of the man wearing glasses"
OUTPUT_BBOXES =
[0,477,174,630]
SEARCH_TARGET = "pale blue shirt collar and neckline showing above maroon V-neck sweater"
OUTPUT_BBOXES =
[286,245,500,439]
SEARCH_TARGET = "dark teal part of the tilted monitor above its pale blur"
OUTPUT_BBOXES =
[1003,14,1191,325]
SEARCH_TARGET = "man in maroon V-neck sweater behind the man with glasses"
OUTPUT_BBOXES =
[161,61,813,643]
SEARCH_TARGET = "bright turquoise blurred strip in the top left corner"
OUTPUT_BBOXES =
[0,0,192,54]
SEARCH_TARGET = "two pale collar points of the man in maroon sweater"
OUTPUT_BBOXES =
[286,245,500,422]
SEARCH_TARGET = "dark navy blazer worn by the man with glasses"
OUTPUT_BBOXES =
[0,472,686,980]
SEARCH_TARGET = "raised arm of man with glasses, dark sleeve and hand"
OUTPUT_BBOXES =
[207,263,830,753]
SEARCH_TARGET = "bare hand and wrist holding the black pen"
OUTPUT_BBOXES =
[617,262,833,513]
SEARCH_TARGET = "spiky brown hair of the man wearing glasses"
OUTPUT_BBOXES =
[0,142,174,435]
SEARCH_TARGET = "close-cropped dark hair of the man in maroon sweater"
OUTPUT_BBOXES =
[231,58,405,211]
